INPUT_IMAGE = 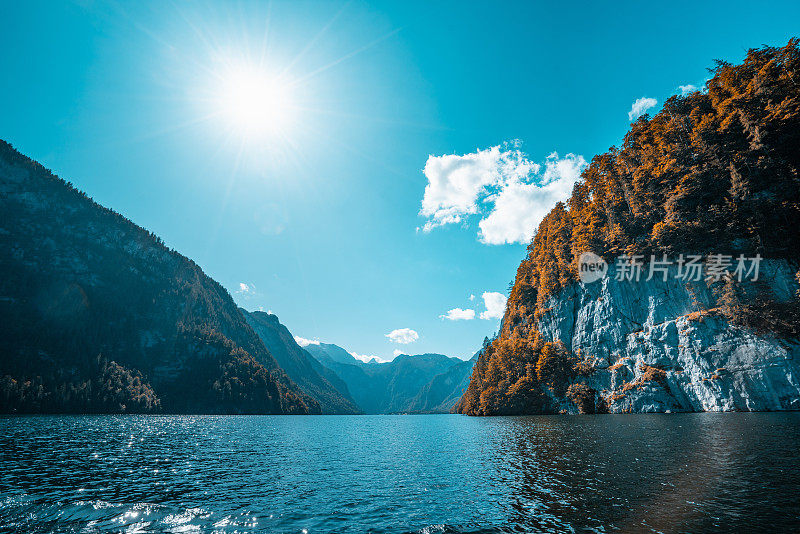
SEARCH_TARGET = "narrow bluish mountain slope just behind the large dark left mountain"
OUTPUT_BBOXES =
[240,309,360,414]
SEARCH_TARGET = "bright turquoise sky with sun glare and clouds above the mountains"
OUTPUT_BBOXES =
[0,1,800,359]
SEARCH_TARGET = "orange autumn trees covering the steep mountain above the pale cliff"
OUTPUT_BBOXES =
[456,39,800,415]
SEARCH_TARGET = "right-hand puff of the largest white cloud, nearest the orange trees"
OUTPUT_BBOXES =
[478,152,586,245]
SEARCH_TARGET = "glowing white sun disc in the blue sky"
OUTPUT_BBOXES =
[215,64,295,138]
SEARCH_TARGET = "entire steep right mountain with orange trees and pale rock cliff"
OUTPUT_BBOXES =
[455,39,800,415]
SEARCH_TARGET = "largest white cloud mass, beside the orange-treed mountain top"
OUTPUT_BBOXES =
[419,141,586,245]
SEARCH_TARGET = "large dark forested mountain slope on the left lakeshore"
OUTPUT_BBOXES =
[0,142,321,414]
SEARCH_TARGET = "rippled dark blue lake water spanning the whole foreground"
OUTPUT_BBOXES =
[0,413,800,533]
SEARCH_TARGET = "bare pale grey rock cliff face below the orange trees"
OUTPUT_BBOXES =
[538,260,800,413]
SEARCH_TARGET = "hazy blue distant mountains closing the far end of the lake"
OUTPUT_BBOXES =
[306,343,474,413]
